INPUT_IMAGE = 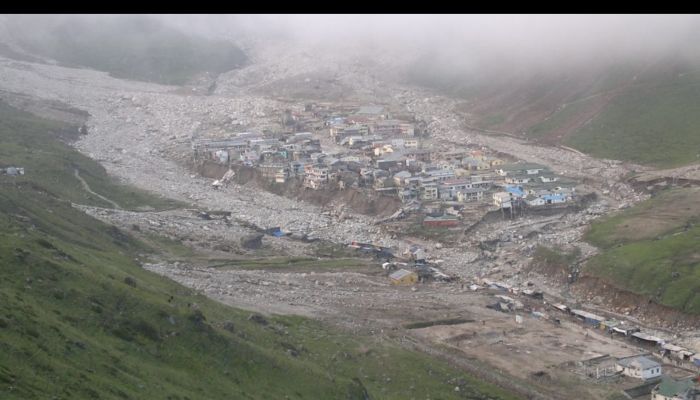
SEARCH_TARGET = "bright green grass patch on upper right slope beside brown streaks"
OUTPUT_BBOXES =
[566,71,700,167]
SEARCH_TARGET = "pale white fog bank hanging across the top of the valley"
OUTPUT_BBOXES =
[4,14,700,76]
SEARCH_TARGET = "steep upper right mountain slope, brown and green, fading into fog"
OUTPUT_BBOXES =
[409,52,700,167]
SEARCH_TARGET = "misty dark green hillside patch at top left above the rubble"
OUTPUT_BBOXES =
[12,15,246,85]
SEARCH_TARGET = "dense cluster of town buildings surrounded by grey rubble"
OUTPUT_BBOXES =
[193,105,574,227]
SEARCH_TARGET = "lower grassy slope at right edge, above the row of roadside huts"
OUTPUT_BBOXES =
[586,188,700,314]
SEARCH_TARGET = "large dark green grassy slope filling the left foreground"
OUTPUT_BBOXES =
[0,101,512,399]
